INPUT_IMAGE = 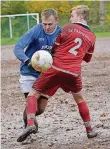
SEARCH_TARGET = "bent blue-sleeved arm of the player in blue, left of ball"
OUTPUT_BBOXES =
[13,26,39,63]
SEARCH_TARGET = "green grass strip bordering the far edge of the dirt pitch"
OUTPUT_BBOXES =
[1,32,110,45]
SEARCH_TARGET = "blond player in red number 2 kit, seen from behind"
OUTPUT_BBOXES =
[17,5,97,142]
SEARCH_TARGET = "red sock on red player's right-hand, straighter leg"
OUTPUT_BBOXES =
[78,101,92,132]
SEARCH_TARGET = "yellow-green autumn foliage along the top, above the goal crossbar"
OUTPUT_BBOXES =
[1,0,110,28]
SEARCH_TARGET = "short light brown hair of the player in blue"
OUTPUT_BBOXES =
[41,8,58,20]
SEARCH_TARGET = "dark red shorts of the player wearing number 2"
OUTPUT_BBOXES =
[33,67,82,96]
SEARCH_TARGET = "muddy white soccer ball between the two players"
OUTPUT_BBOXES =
[31,50,53,72]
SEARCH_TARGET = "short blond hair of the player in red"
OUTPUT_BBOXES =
[71,5,89,21]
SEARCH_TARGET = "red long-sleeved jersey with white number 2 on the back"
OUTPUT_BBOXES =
[52,23,96,76]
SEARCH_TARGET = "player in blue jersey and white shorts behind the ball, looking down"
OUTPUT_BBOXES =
[14,9,61,127]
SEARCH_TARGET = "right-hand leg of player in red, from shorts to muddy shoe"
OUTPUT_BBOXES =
[62,74,97,138]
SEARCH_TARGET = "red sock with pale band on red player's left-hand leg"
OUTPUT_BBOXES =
[26,96,37,126]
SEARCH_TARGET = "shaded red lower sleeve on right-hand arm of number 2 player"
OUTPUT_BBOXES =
[83,45,94,63]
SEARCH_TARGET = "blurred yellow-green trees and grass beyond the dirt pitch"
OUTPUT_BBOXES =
[1,0,110,45]
